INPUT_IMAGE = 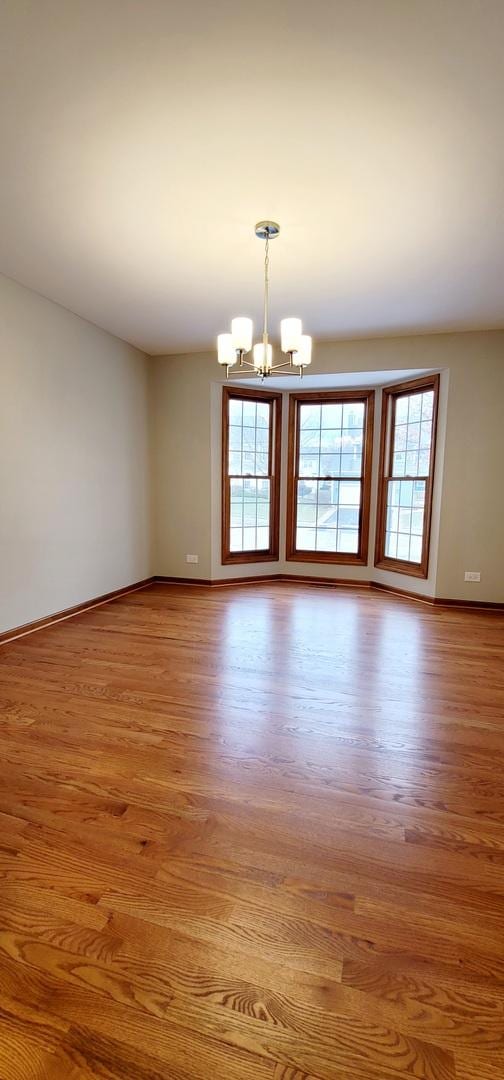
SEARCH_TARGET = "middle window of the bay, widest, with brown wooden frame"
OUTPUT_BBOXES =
[287,390,374,564]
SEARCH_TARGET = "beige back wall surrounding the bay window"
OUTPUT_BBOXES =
[151,330,504,602]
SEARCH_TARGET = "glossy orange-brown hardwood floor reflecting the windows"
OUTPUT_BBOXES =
[0,583,504,1080]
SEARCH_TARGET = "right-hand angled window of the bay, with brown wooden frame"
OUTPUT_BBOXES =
[374,375,439,578]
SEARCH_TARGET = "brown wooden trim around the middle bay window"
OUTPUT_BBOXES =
[286,390,374,566]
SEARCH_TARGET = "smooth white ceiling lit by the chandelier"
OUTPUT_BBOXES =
[0,0,504,353]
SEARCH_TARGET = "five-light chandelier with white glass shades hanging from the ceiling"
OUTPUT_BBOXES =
[217,221,312,380]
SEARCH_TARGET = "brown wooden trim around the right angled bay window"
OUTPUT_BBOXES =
[374,375,439,578]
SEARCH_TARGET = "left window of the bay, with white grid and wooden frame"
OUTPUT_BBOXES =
[222,388,282,563]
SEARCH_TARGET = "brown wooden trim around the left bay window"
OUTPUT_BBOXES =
[221,387,282,566]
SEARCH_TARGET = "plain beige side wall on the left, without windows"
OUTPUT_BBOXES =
[0,276,150,632]
